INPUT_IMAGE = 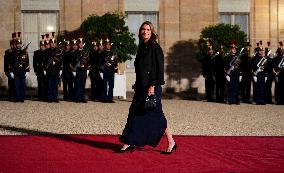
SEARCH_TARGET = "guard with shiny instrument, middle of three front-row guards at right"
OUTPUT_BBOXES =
[252,47,267,105]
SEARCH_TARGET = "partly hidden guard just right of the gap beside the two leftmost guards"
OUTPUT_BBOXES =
[33,35,47,101]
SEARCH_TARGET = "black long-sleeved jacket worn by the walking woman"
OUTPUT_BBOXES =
[134,39,165,87]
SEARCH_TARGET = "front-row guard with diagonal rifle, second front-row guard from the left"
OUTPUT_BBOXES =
[44,32,62,103]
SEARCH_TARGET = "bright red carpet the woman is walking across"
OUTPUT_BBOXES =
[0,134,284,173]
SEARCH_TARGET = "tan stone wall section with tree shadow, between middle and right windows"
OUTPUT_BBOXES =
[160,0,218,92]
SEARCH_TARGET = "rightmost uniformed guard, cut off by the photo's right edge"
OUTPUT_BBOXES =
[273,45,284,105]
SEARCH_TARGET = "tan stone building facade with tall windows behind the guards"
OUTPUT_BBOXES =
[0,0,284,92]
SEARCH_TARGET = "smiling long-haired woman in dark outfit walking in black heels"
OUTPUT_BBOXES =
[120,21,177,154]
